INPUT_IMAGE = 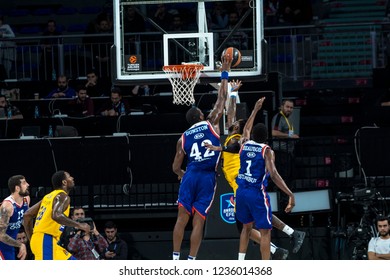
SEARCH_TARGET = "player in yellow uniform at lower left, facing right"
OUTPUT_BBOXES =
[23,171,90,260]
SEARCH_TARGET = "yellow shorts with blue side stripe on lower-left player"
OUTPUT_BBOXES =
[30,233,76,260]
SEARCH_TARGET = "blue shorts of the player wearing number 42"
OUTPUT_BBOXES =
[177,168,216,218]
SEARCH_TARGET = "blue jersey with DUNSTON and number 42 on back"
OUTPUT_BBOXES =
[181,121,220,171]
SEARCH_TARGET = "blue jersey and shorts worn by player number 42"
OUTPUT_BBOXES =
[178,121,220,217]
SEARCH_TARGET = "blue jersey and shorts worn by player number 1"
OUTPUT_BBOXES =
[236,141,272,229]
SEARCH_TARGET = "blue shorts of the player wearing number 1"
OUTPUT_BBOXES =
[236,187,272,229]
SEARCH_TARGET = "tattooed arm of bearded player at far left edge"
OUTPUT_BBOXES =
[0,201,27,260]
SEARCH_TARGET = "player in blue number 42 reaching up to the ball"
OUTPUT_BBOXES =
[172,55,232,260]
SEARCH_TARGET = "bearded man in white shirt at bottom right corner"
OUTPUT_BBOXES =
[367,216,390,260]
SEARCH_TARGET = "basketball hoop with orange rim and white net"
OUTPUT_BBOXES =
[163,64,204,106]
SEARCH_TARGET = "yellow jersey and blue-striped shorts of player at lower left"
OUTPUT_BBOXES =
[30,190,75,260]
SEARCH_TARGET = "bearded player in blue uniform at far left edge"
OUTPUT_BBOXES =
[0,175,30,260]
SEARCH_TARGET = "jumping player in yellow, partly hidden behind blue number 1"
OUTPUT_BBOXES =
[206,83,306,259]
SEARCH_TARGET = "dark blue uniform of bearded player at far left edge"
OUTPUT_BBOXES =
[0,196,28,260]
